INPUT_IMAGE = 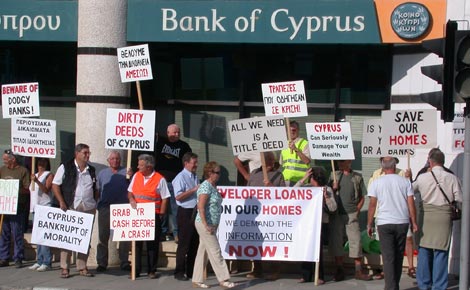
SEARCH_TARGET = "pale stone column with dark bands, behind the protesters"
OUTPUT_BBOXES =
[75,0,130,265]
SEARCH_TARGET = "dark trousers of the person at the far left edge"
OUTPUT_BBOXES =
[0,212,24,262]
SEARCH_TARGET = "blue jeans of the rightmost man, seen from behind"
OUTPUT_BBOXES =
[416,247,449,290]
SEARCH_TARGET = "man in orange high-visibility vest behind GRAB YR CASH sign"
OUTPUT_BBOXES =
[127,154,170,279]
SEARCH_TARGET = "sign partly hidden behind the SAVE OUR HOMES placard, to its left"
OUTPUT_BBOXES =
[361,119,415,158]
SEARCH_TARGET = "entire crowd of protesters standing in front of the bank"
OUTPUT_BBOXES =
[0,121,462,290]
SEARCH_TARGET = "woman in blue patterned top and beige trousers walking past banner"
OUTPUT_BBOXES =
[192,161,236,289]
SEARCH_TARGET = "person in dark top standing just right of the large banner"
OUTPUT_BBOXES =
[328,160,372,281]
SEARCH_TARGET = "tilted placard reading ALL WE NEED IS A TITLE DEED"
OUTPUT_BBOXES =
[228,116,288,155]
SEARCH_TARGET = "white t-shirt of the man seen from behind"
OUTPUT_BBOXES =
[367,174,413,226]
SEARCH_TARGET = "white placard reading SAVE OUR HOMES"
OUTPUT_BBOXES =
[382,110,437,149]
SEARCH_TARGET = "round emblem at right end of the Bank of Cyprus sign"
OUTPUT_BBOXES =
[390,3,431,39]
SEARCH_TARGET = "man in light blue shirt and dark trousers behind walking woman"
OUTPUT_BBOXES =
[172,152,199,281]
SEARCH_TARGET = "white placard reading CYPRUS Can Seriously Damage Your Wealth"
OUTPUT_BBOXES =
[305,122,355,160]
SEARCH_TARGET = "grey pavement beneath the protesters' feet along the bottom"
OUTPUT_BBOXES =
[0,262,436,290]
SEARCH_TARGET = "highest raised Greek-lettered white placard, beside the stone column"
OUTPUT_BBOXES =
[117,44,153,83]
